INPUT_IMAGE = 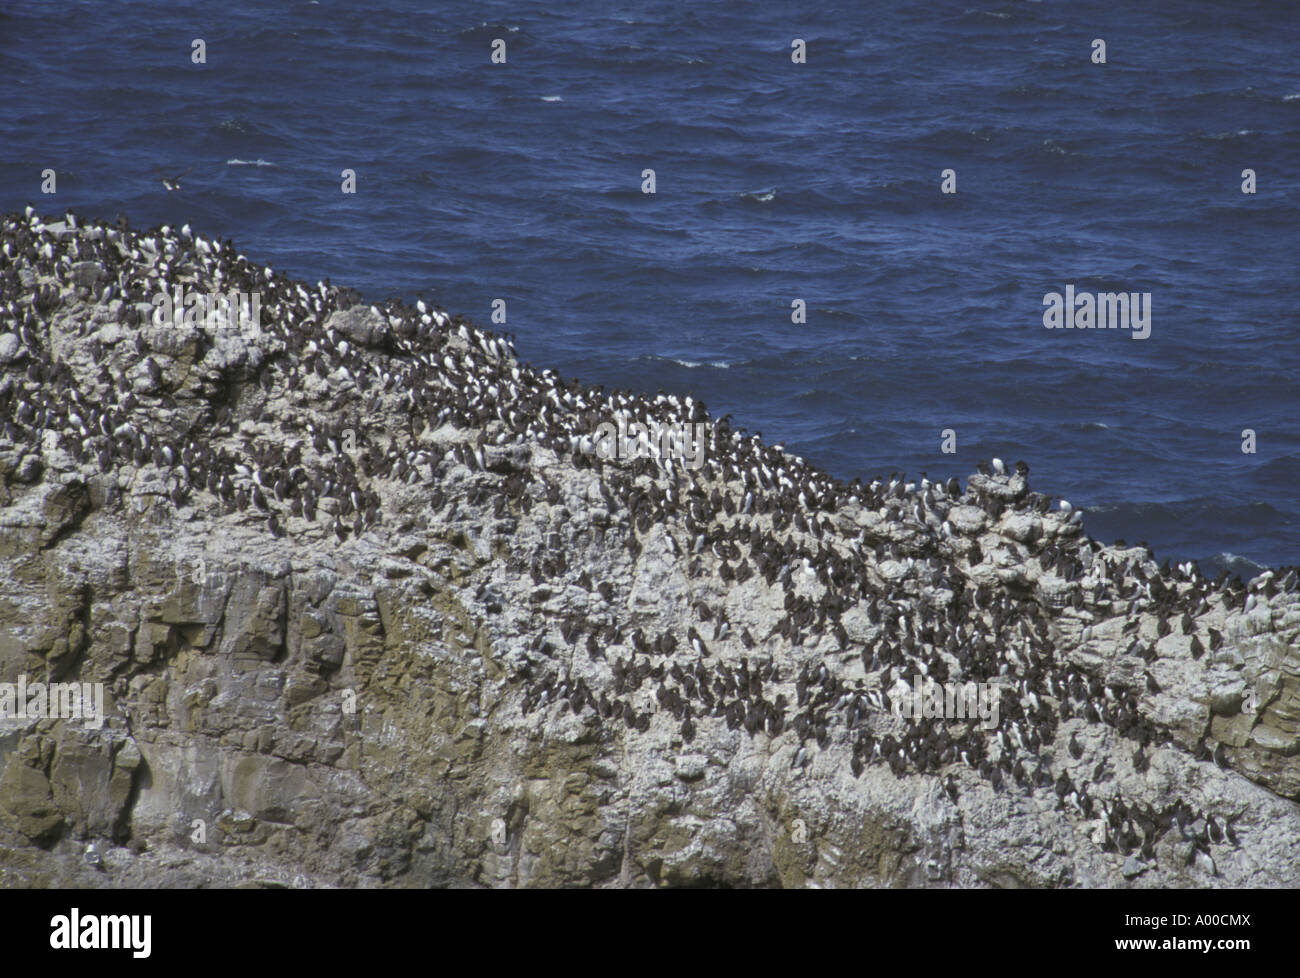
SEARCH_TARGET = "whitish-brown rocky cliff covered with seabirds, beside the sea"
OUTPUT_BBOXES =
[0,215,1300,887]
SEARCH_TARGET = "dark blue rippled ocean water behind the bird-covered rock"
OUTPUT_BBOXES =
[0,0,1300,574]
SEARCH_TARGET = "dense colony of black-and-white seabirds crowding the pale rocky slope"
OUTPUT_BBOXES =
[0,208,1296,867]
